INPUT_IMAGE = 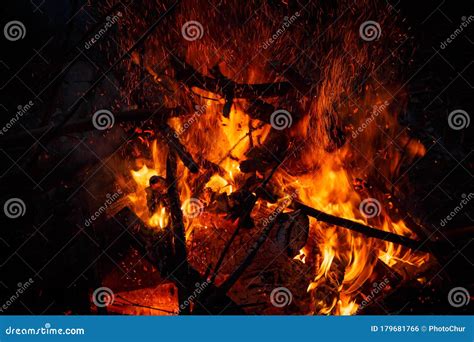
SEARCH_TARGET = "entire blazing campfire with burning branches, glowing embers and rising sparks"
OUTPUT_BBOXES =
[87,0,433,315]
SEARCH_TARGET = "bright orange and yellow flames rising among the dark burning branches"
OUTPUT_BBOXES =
[114,0,429,315]
